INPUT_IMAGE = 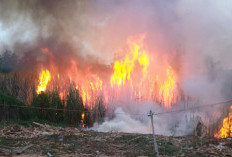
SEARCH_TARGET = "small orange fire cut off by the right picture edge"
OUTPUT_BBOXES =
[214,106,232,138]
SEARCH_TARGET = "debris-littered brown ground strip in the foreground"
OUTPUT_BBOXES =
[0,123,232,157]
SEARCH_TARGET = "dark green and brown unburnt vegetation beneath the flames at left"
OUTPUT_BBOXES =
[0,72,105,126]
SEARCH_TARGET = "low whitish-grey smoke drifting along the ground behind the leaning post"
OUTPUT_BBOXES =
[91,106,218,136]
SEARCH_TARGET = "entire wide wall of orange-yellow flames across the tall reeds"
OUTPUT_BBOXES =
[37,35,180,109]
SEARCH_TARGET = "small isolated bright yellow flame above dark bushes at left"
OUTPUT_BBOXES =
[37,70,51,94]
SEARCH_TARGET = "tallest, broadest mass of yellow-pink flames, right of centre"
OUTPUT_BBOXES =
[110,36,180,108]
